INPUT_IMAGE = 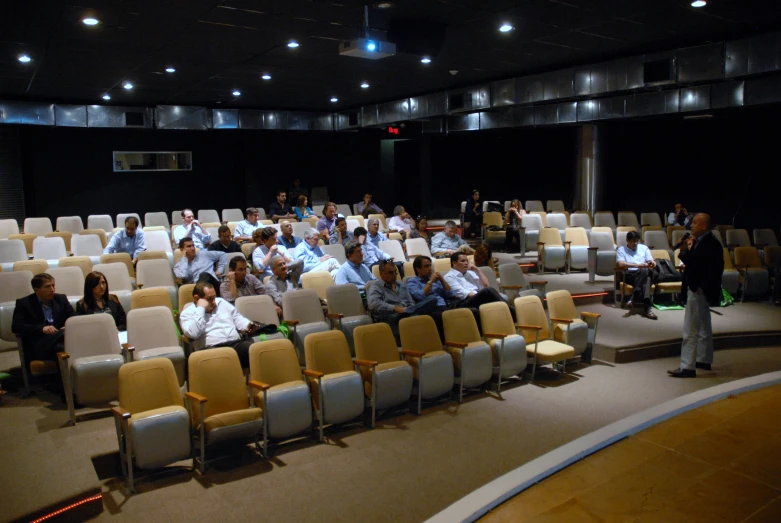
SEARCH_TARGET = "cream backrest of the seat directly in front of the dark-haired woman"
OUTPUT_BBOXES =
[65,312,120,358]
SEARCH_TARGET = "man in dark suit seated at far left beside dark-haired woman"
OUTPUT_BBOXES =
[11,273,76,364]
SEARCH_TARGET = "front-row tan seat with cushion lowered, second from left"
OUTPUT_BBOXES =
[185,347,268,474]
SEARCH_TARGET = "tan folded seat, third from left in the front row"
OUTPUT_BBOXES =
[249,339,312,457]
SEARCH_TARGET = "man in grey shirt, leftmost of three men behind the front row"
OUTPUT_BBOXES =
[366,260,441,341]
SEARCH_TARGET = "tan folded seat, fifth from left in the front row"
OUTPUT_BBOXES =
[355,323,413,427]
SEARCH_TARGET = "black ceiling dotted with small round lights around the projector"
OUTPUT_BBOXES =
[0,0,781,110]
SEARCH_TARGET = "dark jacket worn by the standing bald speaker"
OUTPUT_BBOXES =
[679,232,724,306]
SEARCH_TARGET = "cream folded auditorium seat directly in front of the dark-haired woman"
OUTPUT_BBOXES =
[57,314,125,425]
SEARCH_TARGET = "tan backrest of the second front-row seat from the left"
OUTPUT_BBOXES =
[187,347,249,427]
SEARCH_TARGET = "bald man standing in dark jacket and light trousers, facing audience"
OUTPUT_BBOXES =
[667,213,724,378]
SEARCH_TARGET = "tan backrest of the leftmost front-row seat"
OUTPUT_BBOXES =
[119,358,183,415]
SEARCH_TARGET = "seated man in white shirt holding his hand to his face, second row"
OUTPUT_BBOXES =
[179,282,260,368]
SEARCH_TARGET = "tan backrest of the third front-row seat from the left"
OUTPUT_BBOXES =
[249,339,304,387]
